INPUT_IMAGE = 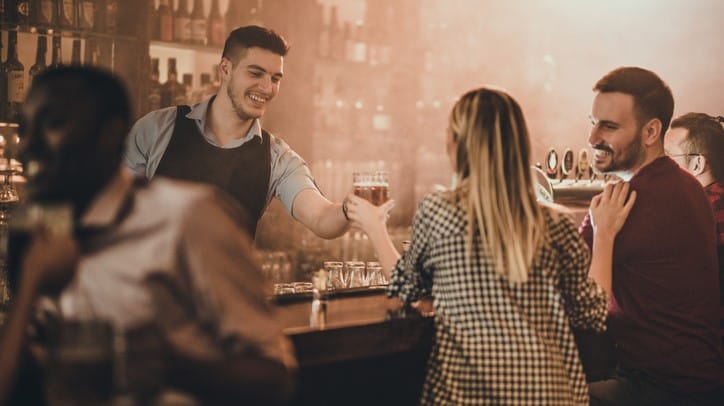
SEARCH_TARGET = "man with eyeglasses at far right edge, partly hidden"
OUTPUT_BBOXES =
[664,113,724,342]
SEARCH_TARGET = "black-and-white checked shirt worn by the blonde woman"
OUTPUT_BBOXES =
[388,193,607,405]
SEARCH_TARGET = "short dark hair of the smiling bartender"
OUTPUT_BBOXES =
[221,25,289,66]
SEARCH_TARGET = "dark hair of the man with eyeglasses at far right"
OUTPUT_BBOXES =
[671,113,724,182]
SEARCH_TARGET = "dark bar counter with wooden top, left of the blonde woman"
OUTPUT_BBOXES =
[276,290,434,405]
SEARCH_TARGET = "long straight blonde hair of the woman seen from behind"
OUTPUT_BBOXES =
[450,87,546,282]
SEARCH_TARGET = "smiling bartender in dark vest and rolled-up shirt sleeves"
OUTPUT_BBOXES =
[124,25,348,239]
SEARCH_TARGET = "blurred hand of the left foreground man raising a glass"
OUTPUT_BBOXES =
[20,229,80,294]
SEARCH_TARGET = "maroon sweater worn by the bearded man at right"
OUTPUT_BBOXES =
[580,157,724,392]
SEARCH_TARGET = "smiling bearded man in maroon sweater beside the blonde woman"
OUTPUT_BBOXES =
[581,67,724,406]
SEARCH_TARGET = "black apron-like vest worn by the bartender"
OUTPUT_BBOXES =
[155,106,271,238]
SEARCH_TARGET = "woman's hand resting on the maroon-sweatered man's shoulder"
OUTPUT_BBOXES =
[590,182,636,239]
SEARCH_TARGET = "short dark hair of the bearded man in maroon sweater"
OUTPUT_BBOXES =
[593,66,674,135]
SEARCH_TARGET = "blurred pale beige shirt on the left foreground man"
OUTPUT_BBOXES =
[51,170,294,365]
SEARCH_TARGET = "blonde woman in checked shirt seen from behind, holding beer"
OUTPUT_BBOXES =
[347,87,635,405]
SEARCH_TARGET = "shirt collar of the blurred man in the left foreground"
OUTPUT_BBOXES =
[79,168,135,229]
